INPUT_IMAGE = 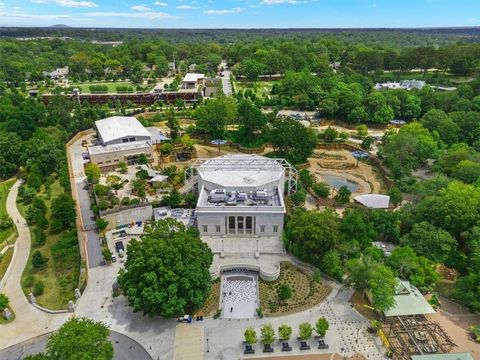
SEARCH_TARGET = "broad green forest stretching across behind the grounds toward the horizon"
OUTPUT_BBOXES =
[0,30,480,86]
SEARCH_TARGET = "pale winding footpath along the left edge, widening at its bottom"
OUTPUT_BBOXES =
[0,181,70,349]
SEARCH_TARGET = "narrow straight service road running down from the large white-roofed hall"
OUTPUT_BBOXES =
[67,135,103,268]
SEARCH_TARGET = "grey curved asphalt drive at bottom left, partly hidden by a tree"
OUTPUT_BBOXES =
[0,331,152,360]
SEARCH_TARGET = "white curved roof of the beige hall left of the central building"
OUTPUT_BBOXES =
[95,116,151,142]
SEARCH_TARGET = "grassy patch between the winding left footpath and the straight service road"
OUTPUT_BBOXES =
[19,181,80,310]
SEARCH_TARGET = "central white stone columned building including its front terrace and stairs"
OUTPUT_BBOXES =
[184,154,297,281]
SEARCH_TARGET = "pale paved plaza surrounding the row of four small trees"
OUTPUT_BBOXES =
[201,284,385,360]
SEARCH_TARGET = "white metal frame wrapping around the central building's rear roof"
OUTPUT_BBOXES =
[184,156,298,194]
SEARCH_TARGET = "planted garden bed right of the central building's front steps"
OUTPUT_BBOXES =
[259,262,332,316]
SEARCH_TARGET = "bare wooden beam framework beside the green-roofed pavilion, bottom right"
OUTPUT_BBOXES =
[379,315,456,360]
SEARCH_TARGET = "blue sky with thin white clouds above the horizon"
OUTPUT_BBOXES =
[0,0,480,28]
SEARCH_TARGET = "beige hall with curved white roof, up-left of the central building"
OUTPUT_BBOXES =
[88,116,153,170]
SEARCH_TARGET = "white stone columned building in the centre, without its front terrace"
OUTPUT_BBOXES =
[188,154,295,238]
